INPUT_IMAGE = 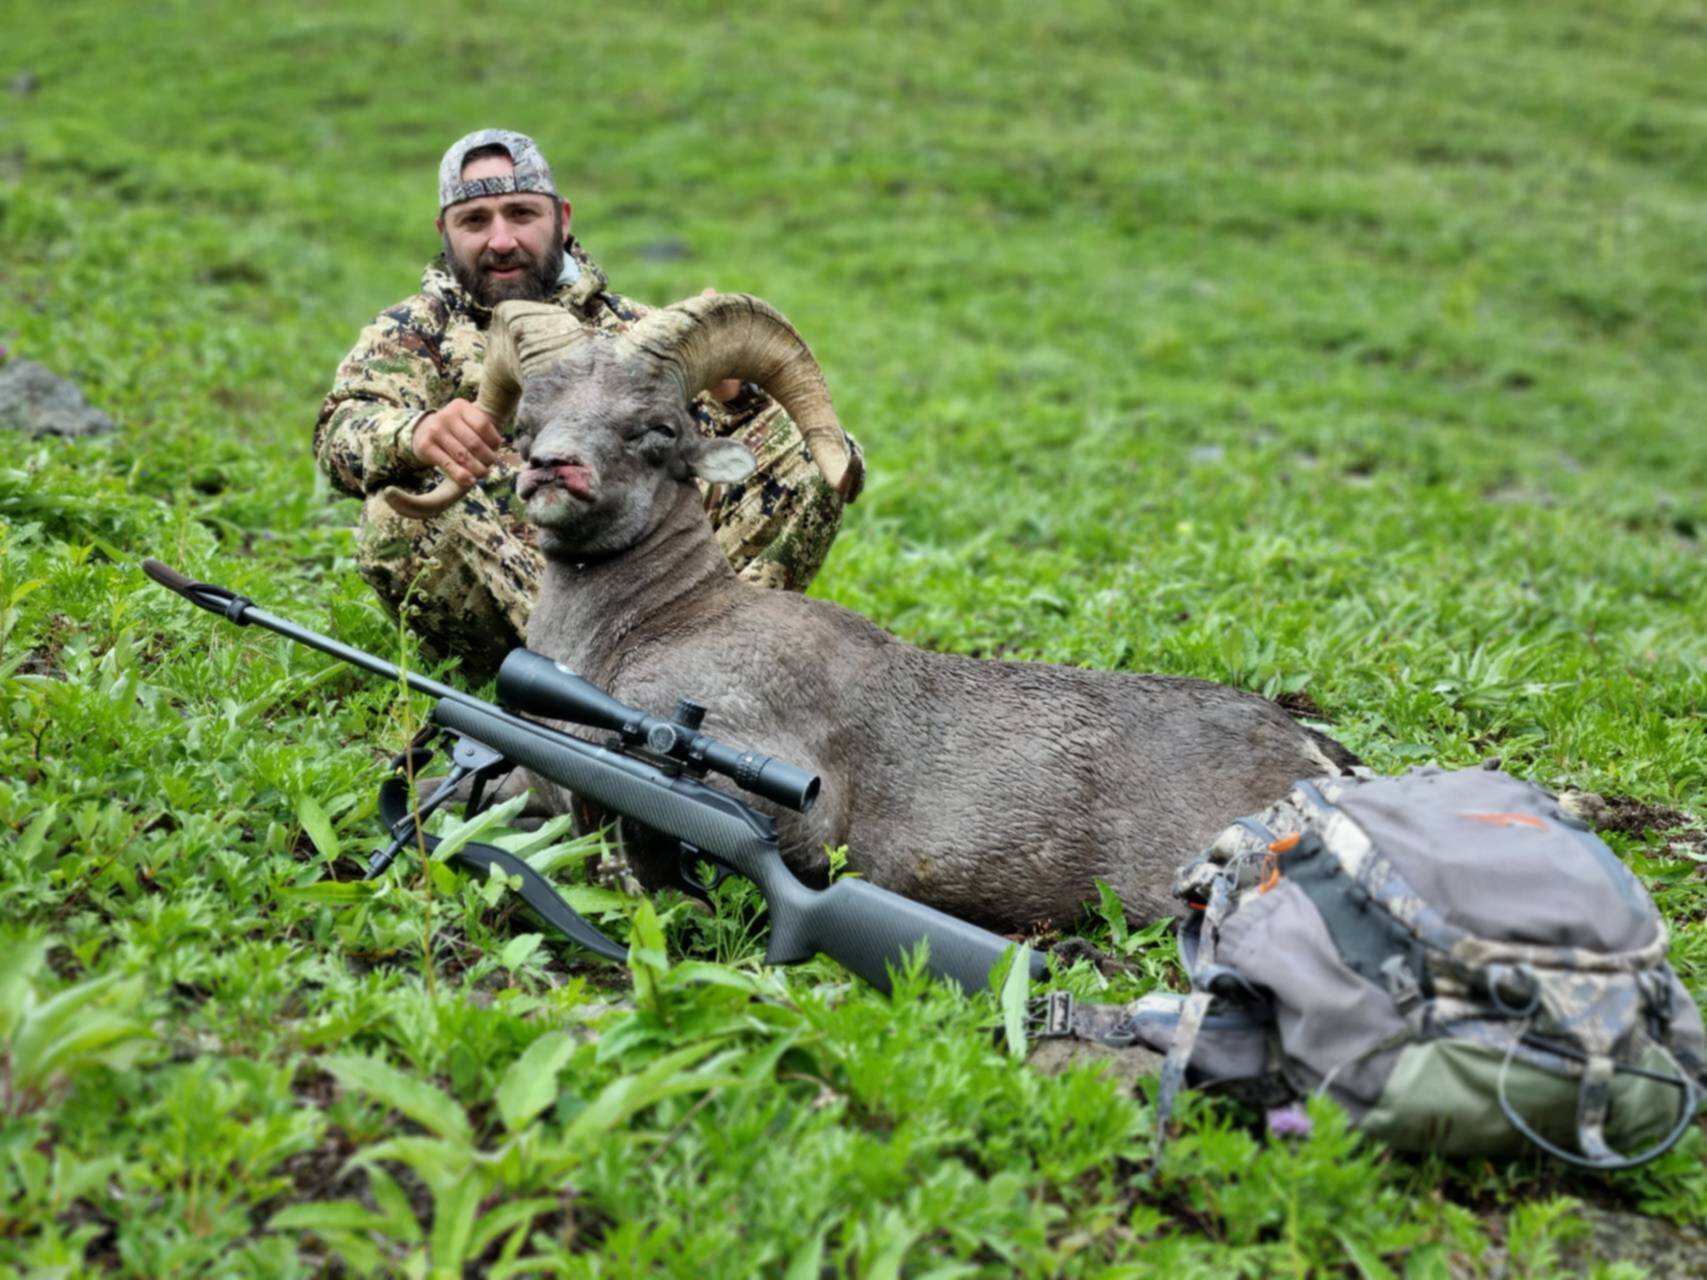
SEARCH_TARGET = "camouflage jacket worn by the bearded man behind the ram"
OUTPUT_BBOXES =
[314,237,773,498]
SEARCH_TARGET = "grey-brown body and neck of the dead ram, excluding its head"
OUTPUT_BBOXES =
[527,485,1345,928]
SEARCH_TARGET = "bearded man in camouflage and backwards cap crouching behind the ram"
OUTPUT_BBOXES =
[314,130,862,679]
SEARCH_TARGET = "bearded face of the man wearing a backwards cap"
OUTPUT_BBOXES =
[439,155,568,307]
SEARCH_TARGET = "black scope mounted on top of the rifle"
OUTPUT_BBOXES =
[498,649,818,814]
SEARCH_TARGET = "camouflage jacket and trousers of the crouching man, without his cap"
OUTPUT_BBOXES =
[314,239,859,679]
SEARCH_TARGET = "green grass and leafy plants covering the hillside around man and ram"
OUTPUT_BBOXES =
[0,0,1707,1277]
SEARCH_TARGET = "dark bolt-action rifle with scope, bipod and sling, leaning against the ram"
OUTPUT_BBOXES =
[142,560,1045,992]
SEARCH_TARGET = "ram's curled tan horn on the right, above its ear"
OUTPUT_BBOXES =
[623,294,864,502]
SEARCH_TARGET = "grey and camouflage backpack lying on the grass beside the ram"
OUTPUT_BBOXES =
[1045,768,1707,1169]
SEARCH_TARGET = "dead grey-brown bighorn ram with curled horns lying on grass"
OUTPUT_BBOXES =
[390,294,1355,930]
